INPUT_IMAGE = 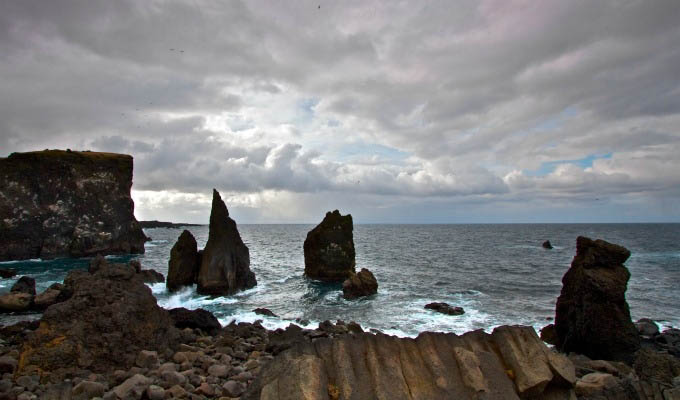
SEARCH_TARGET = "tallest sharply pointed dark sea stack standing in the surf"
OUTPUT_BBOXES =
[197,189,257,296]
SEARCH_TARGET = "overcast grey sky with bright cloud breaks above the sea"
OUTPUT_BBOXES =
[0,0,680,223]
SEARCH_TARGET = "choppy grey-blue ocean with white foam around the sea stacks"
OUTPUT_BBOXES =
[0,224,680,336]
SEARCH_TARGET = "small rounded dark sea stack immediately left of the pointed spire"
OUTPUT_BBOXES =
[165,230,201,292]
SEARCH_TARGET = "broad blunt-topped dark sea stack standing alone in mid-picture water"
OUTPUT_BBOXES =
[304,210,356,282]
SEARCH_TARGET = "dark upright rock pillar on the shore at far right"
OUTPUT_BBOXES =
[555,236,640,361]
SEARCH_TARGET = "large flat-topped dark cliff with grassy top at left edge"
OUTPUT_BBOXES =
[0,150,146,261]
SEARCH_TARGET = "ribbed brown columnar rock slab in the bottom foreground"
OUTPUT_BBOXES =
[243,326,576,400]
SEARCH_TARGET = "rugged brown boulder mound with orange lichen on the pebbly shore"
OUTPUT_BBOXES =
[19,256,180,377]
